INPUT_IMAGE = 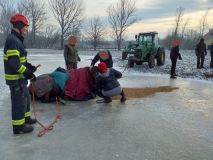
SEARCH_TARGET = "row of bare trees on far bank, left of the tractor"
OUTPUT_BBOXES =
[0,0,136,50]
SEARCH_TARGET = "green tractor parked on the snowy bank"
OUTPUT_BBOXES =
[122,32,165,68]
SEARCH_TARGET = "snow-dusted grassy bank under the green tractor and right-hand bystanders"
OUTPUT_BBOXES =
[111,50,213,81]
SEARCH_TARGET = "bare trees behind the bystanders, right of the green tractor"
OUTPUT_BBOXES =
[161,7,212,49]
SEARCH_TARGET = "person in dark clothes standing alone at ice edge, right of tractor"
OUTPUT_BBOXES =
[170,45,182,79]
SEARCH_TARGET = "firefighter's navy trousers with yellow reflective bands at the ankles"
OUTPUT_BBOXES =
[9,84,30,126]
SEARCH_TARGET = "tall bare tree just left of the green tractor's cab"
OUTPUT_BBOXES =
[107,0,137,50]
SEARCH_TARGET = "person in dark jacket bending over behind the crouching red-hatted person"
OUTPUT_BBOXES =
[91,50,113,68]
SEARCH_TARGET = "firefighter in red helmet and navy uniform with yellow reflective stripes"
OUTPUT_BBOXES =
[4,14,36,134]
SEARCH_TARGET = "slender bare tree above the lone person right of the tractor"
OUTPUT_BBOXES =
[173,7,184,38]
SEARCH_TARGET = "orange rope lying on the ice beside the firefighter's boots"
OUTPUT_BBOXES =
[31,82,61,137]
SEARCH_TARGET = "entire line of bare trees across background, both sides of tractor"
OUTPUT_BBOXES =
[0,0,211,50]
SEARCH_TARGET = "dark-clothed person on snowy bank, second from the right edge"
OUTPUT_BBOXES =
[195,38,207,69]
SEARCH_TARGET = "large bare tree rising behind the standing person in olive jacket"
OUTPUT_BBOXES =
[49,0,83,49]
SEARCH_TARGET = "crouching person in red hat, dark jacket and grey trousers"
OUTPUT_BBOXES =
[96,62,126,103]
